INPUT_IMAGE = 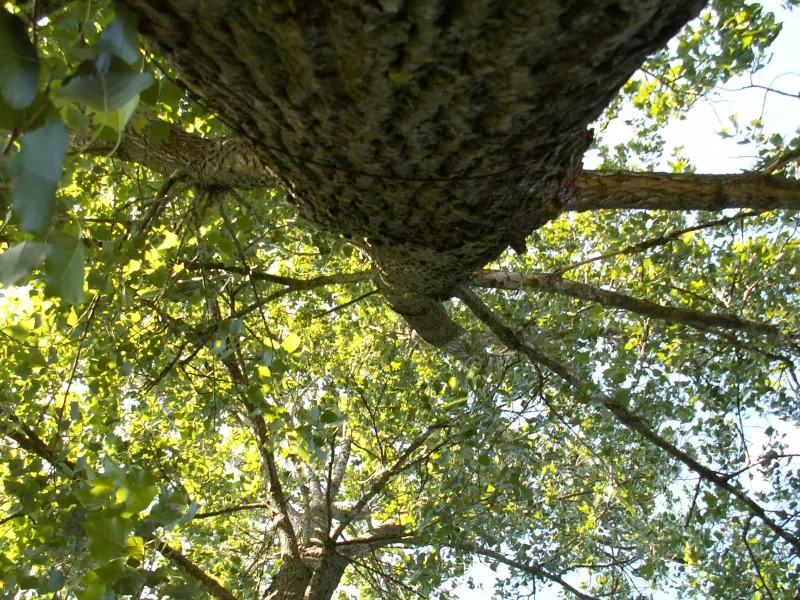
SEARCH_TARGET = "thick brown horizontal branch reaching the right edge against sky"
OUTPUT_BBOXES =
[565,171,800,212]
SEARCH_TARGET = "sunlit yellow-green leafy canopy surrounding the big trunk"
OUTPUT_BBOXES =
[0,0,800,600]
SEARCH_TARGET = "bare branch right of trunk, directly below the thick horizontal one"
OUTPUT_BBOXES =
[472,271,781,334]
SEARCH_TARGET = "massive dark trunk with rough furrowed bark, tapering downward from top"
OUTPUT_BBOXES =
[120,0,702,345]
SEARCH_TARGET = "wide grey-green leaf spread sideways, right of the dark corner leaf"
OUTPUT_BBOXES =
[58,53,153,112]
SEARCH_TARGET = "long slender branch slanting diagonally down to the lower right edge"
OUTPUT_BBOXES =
[458,286,800,553]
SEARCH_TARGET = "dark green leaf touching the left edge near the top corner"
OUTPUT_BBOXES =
[0,10,42,109]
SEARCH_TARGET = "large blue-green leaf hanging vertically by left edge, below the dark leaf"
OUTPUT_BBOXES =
[11,116,69,233]
